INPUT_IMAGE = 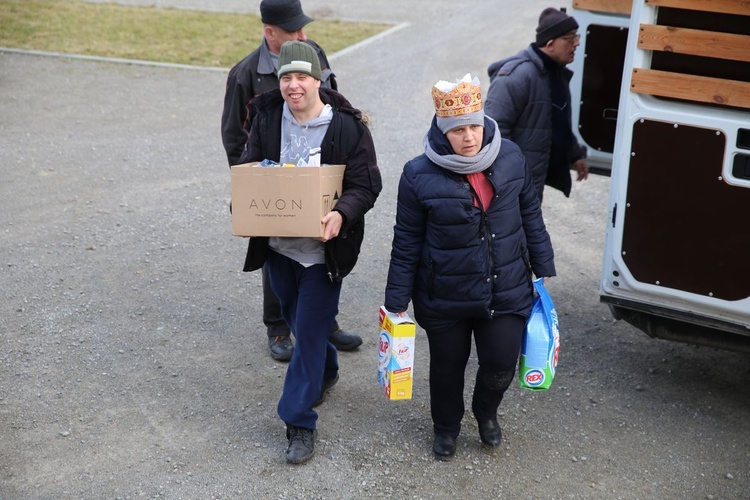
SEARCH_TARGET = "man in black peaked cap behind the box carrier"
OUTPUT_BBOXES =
[221,0,362,361]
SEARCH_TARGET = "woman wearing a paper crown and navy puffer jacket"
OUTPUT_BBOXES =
[384,75,555,459]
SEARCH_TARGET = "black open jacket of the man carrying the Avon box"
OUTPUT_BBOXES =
[240,88,383,281]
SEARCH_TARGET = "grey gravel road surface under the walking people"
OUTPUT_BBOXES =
[0,0,750,500]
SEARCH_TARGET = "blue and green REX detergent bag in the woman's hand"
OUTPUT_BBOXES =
[518,278,560,391]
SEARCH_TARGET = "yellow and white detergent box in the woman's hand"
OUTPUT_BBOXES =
[378,306,417,399]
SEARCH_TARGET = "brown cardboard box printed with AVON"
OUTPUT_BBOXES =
[232,163,345,237]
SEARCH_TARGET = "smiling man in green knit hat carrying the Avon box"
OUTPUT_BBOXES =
[240,41,382,463]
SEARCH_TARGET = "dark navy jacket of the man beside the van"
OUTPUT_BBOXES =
[484,46,586,196]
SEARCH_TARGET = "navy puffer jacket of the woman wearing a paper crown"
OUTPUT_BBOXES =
[385,119,555,331]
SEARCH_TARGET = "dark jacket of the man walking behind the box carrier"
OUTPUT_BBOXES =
[221,40,338,167]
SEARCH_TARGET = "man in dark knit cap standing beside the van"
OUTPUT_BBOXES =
[484,7,589,200]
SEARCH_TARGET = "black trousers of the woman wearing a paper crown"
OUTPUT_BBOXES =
[427,314,526,437]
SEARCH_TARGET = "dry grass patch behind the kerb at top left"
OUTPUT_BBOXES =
[0,0,389,67]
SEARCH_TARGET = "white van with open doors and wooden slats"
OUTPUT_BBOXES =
[570,0,750,352]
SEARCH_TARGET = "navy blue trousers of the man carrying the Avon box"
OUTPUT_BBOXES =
[266,251,341,429]
